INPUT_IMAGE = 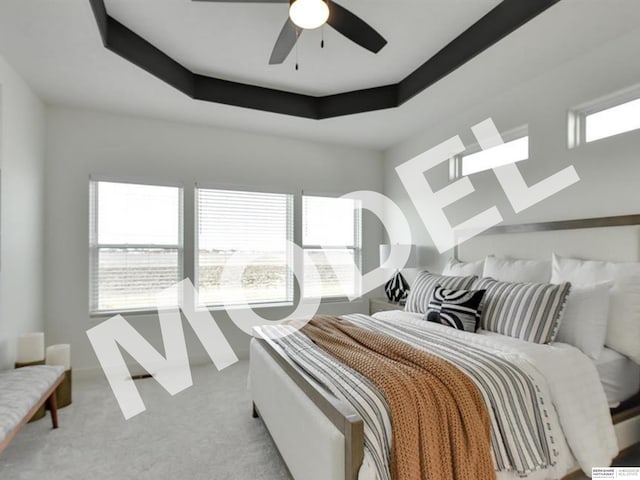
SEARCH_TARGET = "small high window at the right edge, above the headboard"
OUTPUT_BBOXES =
[569,88,640,147]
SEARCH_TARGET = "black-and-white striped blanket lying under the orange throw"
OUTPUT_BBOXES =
[257,314,559,480]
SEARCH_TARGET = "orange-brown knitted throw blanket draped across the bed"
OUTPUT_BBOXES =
[302,315,496,480]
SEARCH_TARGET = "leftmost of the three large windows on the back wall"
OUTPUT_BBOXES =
[89,181,182,313]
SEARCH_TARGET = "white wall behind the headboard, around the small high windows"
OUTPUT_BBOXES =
[384,23,640,276]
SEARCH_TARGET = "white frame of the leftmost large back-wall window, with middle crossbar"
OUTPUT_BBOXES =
[88,175,185,318]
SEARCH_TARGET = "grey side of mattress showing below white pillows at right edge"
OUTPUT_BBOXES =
[593,347,640,408]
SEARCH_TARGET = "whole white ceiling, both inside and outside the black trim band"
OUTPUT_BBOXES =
[0,0,640,149]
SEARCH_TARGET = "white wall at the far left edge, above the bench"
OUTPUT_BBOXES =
[0,56,45,369]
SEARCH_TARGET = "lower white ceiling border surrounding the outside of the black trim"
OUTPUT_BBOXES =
[0,0,640,146]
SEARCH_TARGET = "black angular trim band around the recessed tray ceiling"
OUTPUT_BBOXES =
[89,0,560,120]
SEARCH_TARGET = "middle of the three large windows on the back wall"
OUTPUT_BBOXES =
[196,189,293,306]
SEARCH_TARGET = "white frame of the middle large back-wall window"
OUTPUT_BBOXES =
[193,182,299,311]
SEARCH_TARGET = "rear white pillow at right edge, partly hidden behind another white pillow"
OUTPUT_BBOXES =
[551,254,640,363]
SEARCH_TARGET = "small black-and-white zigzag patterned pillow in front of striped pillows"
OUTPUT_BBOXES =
[426,285,485,332]
